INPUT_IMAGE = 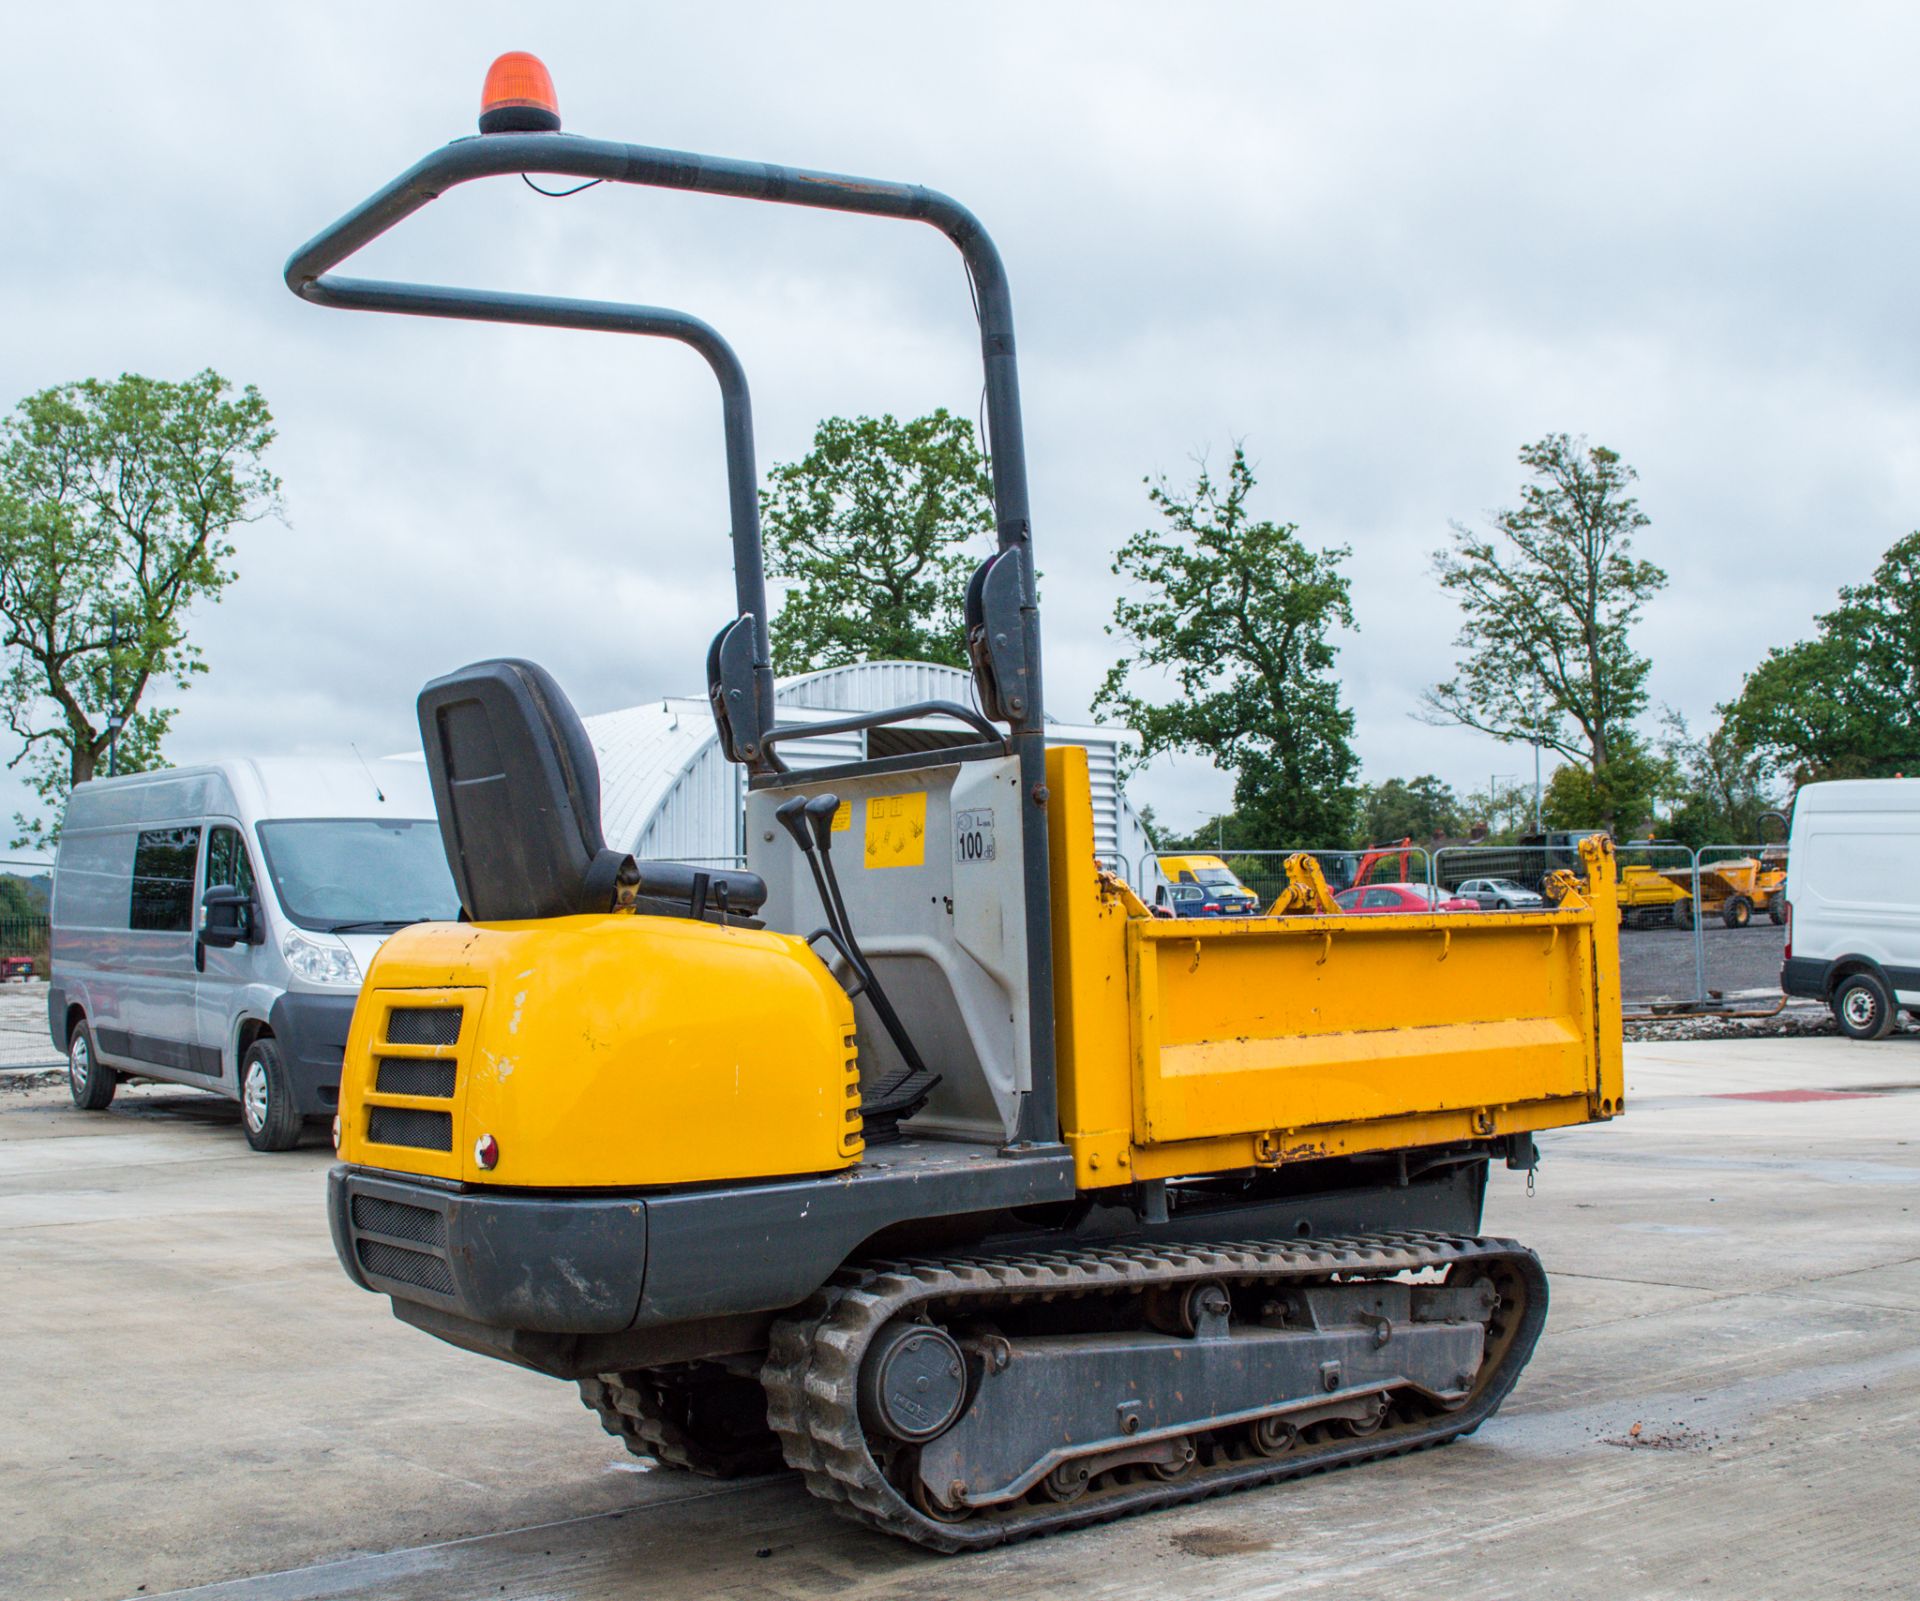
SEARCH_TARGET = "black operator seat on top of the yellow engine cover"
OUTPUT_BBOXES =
[419,658,766,923]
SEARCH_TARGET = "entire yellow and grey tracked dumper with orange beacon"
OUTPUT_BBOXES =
[286,58,1622,1551]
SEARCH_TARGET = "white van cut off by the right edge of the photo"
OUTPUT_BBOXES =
[1780,777,1920,1040]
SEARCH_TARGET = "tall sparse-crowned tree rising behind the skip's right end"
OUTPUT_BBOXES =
[1423,434,1667,821]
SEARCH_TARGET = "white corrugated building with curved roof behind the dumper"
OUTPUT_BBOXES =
[586,662,1150,873]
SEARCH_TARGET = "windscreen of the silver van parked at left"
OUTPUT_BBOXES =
[259,818,461,933]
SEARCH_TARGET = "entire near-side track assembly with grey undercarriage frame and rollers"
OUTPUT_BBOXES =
[760,1234,1546,1551]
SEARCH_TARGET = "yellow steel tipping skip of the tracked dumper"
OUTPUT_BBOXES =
[1046,747,1622,1188]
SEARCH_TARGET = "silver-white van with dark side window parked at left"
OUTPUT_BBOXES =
[46,758,459,1150]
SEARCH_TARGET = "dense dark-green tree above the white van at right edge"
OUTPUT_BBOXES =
[1726,534,1920,783]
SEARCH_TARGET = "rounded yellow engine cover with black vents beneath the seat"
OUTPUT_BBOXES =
[340,914,862,1188]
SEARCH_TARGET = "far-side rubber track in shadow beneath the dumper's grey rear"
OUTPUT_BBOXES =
[580,1363,785,1478]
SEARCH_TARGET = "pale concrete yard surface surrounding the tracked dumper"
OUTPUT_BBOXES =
[0,1037,1920,1601]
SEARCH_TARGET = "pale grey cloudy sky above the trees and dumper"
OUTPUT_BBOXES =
[0,0,1920,860]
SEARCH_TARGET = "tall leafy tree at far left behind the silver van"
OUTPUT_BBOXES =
[0,372,280,847]
